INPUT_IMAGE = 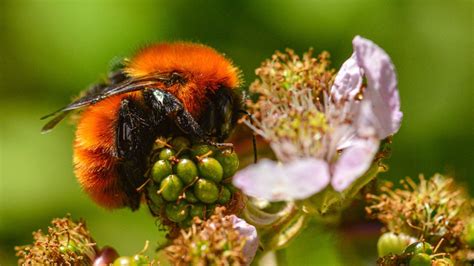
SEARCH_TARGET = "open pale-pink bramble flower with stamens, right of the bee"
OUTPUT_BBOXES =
[233,36,402,201]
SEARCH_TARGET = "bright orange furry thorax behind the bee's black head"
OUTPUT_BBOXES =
[125,42,240,117]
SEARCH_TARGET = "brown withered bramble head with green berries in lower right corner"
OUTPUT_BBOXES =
[366,174,474,265]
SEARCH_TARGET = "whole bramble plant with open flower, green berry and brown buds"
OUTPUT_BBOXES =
[17,36,474,265]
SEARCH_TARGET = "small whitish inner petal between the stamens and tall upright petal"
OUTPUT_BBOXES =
[331,53,362,102]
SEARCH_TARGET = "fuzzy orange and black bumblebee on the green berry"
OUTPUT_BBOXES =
[43,42,242,210]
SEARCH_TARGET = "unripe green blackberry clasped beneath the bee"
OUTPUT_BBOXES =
[146,137,239,228]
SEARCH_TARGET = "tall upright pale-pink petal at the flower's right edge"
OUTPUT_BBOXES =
[352,36,403,139]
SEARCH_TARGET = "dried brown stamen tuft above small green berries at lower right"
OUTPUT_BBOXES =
[366,174,472,249]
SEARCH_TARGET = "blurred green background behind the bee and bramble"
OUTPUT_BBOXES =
[0,0,474,265]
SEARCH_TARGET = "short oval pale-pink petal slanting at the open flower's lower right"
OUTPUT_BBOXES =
[331,139,379,191]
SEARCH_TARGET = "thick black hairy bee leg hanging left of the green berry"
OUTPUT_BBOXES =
[115,99,154,210]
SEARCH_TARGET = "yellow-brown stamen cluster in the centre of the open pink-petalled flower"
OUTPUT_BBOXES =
[246,49,334,160]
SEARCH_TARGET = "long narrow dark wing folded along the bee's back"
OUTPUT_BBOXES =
[41,73,175,133]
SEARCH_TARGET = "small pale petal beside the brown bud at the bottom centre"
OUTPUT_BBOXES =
[231,215,258,265]
